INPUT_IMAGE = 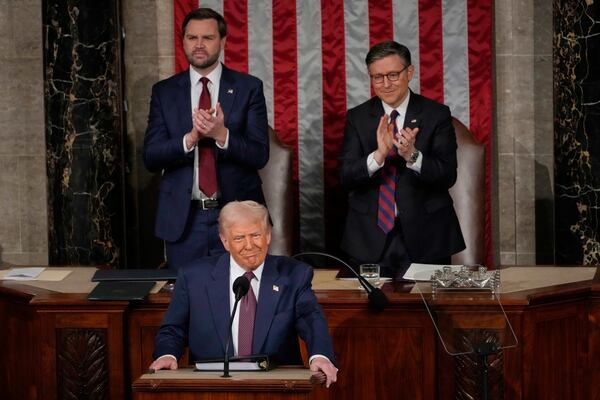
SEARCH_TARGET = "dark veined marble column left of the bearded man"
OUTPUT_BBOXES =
[42,0,125,266]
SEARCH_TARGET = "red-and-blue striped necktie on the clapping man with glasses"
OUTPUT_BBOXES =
[377,110,399,234]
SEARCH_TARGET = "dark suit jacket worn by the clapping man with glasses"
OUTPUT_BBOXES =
[340,92,465,262]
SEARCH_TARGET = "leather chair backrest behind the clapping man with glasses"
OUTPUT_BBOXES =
[450,118,485,265]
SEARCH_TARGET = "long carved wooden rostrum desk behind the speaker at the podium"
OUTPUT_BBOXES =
[0,267,600,400]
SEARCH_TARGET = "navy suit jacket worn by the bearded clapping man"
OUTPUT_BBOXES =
[144,66,269,242]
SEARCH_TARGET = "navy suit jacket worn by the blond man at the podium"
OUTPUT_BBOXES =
[154,253,335,364]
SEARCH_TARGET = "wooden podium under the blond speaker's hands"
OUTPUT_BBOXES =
[132,368,313,400]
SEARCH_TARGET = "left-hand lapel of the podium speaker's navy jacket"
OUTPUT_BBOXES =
[206,253,233,355]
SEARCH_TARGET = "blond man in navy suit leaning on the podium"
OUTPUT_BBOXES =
[150,201,337,387]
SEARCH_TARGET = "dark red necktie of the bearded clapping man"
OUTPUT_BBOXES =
[198,76,217,197]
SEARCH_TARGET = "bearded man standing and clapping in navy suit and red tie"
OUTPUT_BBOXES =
[144,8,269,268]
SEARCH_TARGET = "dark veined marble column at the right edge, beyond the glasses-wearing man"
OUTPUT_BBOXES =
[553,0,600,265]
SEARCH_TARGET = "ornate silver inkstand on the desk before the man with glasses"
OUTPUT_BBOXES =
[431,265,500,295]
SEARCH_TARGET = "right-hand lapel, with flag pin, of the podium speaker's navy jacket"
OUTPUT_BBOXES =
[252,256,285,353]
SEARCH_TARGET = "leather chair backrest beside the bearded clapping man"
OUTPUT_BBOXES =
[258,127,294,256]
